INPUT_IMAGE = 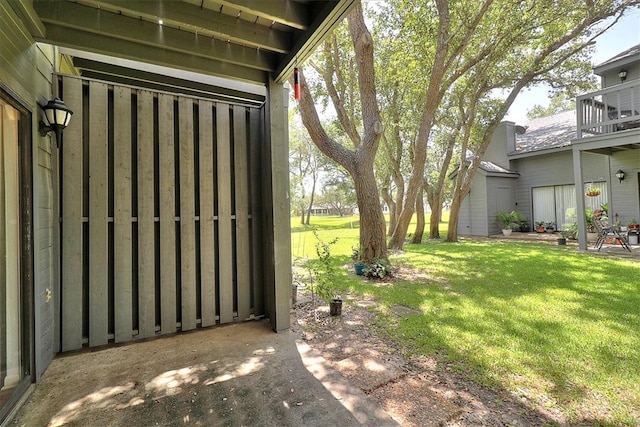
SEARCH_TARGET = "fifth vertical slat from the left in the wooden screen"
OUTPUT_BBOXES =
[158,94,176,334]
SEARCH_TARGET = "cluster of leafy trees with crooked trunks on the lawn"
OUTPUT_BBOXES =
[292,0,638,254]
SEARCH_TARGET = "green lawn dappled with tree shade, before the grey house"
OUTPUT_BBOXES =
[292,217,640,425]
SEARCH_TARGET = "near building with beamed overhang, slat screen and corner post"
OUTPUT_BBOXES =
[0,0,357,424]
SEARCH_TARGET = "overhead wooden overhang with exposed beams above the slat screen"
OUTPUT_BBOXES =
[27,0,359,85]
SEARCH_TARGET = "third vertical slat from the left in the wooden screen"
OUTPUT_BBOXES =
[113,86,133,342]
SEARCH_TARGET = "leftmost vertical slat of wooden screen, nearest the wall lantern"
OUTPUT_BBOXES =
[60,79,84,351]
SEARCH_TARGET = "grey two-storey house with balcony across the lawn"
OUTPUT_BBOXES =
[458,45,640,249]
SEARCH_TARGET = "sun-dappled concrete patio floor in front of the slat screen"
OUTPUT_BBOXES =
[9,321,397,426]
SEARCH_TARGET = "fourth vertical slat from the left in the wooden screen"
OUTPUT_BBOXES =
[138,90,156,338]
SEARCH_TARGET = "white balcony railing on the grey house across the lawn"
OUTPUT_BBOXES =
[576,80,640,138]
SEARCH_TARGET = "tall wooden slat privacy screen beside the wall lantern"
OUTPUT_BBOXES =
[61,77,265,351]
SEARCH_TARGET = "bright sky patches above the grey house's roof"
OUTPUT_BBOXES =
[505,9,640,124]
